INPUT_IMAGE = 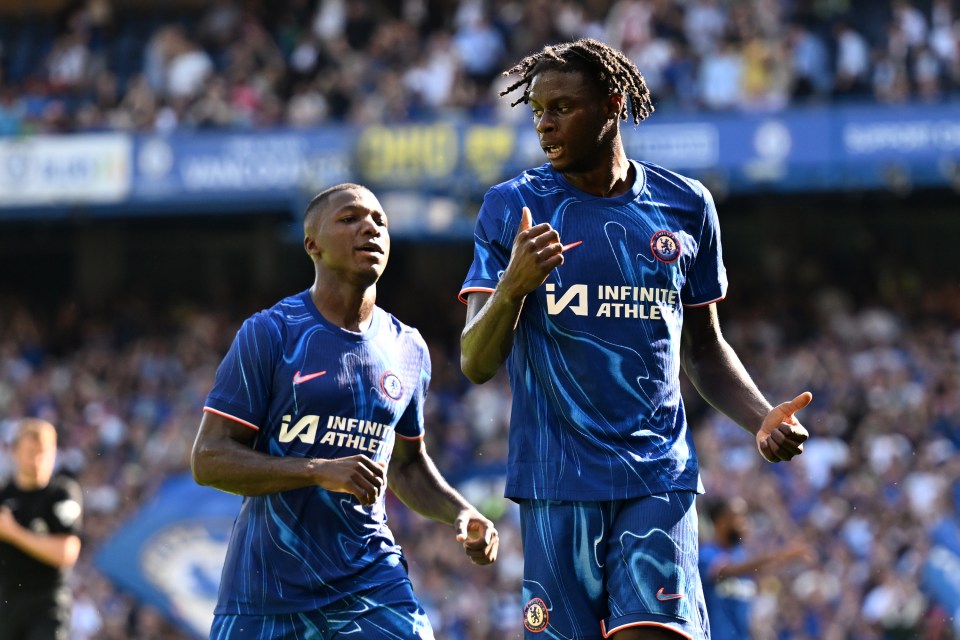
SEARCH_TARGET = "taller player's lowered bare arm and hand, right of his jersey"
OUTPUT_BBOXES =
[680,304,813,462]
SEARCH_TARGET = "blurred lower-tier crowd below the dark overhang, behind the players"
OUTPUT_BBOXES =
[0,268,960,640]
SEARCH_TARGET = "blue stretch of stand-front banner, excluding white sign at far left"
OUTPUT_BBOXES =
[130,105,960,203]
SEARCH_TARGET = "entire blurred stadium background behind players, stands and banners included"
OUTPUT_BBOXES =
[0,0,960,640]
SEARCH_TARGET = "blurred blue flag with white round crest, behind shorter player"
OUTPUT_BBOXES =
[94,474,241,638]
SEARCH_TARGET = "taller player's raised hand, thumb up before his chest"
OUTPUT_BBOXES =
[500,207,563,298]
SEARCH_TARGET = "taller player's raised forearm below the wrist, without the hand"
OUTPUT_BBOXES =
[460,287,523,384]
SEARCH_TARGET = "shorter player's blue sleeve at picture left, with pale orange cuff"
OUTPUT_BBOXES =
[204,312,281,429]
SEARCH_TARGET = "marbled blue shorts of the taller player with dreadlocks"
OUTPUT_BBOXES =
[520,491,710,640]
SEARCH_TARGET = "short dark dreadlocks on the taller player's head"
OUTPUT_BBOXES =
[500,38,653,124]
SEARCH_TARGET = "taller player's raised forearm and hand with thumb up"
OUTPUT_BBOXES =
[460,207,563,384]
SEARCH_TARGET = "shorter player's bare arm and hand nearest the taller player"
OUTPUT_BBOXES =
[387,438,500,565]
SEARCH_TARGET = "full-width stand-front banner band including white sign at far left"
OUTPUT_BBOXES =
[0,104,960,237]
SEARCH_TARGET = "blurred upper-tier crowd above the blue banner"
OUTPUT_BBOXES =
[0,0,960,135]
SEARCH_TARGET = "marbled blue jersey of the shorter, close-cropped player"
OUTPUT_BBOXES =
[204,291,430,615]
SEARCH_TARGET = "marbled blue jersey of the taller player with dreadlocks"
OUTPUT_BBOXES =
[460,162,727,500]
